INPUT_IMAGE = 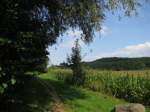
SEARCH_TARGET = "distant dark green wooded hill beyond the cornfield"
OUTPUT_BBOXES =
[83,57,150,70]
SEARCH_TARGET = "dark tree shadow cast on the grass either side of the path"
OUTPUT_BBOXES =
[0,76,86,112]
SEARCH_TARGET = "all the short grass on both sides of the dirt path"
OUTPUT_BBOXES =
[0,69,150,112]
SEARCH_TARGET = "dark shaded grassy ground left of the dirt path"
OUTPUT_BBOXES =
[0,76,53,112]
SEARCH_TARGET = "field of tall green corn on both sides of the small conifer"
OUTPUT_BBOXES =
[47,69,150,105]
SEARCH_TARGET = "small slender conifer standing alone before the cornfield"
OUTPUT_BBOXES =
[68,39,85,86]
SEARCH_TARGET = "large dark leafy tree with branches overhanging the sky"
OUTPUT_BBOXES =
[0,0,141,93]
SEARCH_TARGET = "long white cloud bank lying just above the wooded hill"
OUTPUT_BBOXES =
[86,42,150,60]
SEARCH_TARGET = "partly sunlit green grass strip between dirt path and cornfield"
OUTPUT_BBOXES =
[40,74,150,112]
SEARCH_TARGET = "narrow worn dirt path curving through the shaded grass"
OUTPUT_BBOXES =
[39,80,64,112]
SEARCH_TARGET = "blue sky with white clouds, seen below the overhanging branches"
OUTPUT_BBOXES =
[48,4,150,65]
